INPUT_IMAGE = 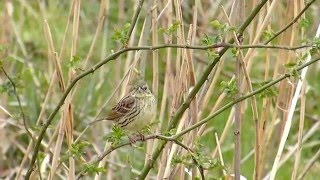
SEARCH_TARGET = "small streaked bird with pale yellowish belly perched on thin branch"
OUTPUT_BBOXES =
[104,80,157,133]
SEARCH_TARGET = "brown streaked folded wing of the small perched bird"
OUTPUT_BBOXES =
[104,95,136,121]
